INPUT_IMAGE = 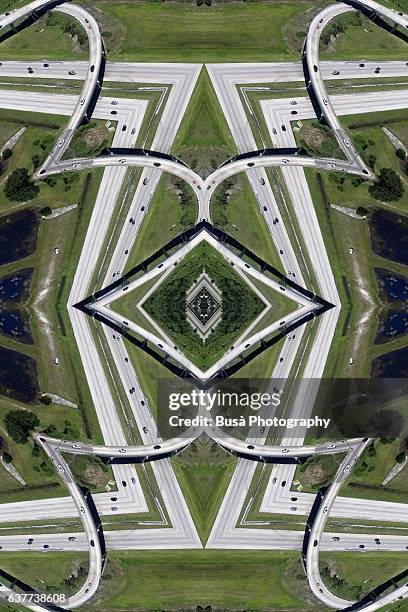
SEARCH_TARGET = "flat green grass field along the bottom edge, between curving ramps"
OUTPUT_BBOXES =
[95,550,319,612]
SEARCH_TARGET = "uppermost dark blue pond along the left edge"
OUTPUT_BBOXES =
[0,208,39,265]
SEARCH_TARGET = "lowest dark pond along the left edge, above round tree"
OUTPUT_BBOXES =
[0,346,39,404]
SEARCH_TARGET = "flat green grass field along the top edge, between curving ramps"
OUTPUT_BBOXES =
[81,0,317,62]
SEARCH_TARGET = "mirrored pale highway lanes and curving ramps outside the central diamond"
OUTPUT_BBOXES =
[0,0,408,610]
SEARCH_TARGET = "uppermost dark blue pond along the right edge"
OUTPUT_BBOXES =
[369,208,408,265]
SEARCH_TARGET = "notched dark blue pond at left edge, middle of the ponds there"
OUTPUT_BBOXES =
[0,268,33,344]
